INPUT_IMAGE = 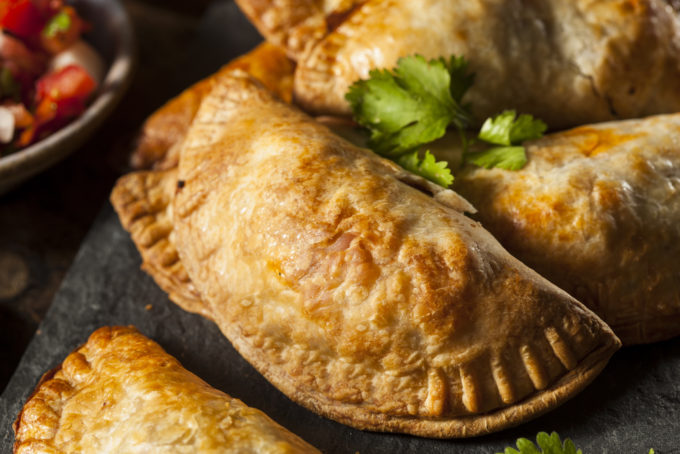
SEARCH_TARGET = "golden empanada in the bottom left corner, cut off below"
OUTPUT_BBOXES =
[14,327,318,454]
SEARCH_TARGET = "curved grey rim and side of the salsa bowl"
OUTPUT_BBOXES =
[0,0,136,194]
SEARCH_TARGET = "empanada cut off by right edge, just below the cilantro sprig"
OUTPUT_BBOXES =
[446,114,680,344]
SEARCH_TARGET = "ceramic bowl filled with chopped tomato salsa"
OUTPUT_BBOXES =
[0,0,134,193]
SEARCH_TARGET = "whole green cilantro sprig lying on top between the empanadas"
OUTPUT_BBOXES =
[345,55,546,187]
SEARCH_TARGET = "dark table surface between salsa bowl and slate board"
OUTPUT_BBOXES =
[0,0,216,391]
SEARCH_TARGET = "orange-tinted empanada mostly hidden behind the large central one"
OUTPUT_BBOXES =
[131,42,294,169]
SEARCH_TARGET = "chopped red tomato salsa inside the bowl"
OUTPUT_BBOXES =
[0,0,104,157]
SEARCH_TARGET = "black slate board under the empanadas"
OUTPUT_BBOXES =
[0,2,680,454]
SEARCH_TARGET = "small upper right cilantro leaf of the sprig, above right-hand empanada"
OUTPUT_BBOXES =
[479,110,548,146]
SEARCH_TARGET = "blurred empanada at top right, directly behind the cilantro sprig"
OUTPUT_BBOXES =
[294,0,680,129]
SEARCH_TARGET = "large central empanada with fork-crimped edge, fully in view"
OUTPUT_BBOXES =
[113,73,619,437]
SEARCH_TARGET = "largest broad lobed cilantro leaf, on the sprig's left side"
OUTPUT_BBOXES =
[346,55,471,158]
